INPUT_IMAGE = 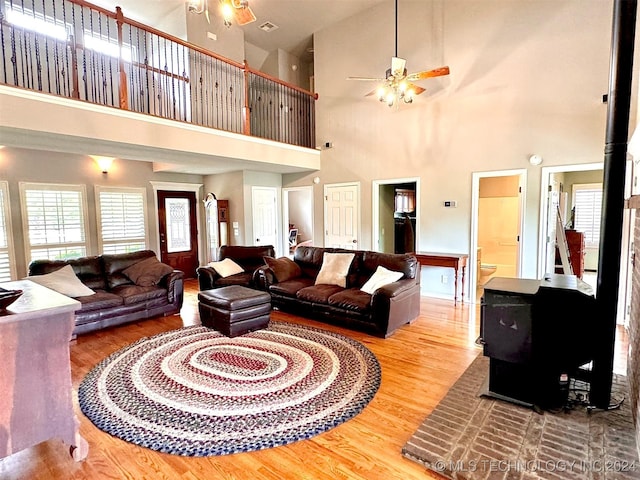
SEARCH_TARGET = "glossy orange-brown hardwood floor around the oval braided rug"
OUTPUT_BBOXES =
[0,280,626,480]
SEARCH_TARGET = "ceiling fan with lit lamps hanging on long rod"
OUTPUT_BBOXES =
[347,0,449,107]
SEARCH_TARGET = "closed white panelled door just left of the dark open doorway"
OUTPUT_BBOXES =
[324,183,360,250]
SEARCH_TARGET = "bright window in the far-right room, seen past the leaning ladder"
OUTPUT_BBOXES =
[573,183,602,247]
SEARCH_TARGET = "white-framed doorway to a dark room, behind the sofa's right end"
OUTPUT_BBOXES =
[372,177,420,253]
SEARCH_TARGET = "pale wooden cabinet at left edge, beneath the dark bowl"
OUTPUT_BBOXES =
[0,280,89,461]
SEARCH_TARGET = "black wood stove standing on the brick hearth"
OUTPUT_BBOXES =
[478,274,598,408]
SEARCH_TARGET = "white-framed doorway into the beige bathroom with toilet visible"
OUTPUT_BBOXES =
[469,169,526,303]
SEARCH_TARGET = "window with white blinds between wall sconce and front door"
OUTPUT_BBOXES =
[96,186,148,253]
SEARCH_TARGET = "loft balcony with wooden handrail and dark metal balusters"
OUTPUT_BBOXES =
[0,0,320,174]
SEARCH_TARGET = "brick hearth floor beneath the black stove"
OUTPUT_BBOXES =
[402,355,640,480]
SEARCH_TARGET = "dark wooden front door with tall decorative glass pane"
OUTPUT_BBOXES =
[158,190,199,278]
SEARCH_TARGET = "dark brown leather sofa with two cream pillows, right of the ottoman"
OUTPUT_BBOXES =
[256,246,420,337]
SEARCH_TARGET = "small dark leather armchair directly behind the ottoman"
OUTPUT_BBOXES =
[196,245,276,291]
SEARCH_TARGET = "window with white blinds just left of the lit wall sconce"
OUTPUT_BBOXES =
[20,182,89,263]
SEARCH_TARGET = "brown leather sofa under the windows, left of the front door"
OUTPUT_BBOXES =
[29,250,184,336]
